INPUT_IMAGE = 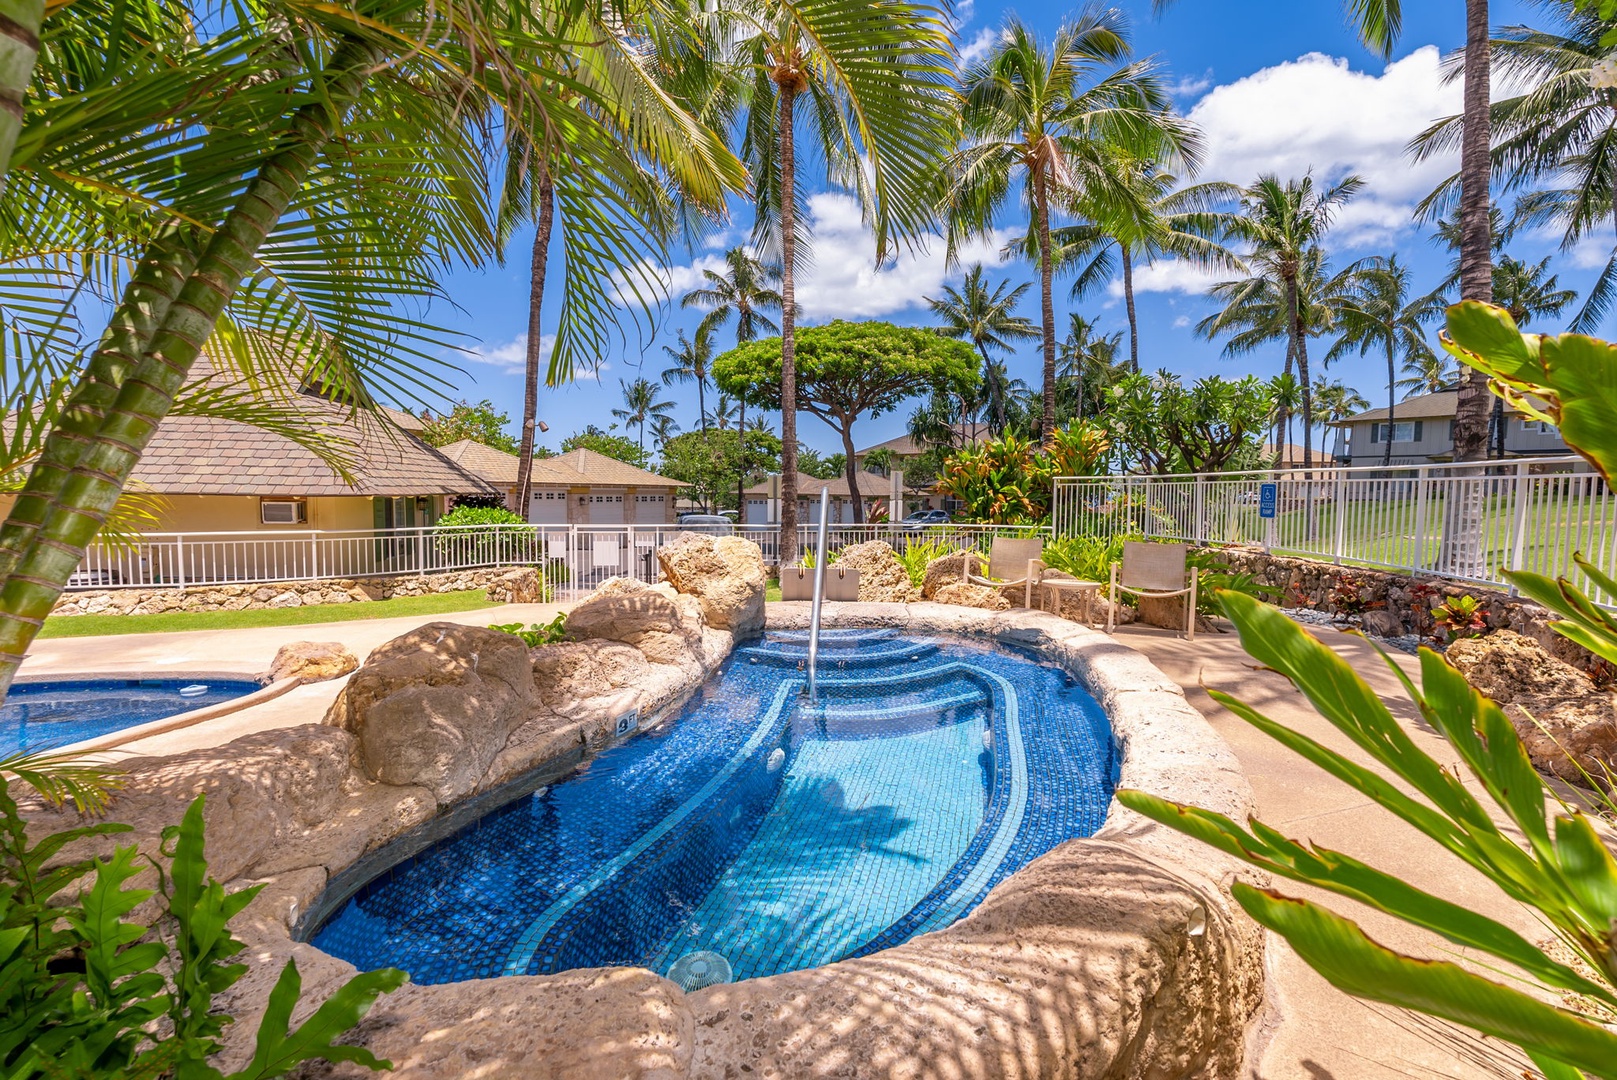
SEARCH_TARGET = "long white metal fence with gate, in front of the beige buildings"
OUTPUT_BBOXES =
[68,524,1027,595]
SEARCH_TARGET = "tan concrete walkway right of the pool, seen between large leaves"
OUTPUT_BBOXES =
[1117,626,1549,1080]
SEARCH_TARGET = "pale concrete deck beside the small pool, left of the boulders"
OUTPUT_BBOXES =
[21,603,569,760]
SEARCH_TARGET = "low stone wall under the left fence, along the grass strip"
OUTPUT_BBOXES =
[50,566,537,616]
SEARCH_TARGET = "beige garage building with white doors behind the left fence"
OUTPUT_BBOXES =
[441,440,684,525]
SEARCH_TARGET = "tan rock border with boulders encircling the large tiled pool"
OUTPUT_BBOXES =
[31,537,1263,1080]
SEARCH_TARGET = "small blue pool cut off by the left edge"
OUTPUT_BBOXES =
[0,679,262,753]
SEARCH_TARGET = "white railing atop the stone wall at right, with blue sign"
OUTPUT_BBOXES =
[1053,458,1617,605]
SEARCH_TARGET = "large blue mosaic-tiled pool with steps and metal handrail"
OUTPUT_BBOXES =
[312,631,1119,988]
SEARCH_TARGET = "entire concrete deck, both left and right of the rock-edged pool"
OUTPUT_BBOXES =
[23,603,1547,1080]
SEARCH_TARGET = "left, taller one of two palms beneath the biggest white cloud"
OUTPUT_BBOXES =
[1232,175,1365,464]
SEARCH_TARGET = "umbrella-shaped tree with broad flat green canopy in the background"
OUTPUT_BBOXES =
[713,320,978,522]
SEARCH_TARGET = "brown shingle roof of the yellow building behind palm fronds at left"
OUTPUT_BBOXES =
[118,357,498,496]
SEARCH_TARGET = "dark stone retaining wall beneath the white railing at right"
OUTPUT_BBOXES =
[1218,548,1617,682]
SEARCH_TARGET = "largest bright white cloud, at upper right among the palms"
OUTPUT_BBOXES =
[1188,45,1460,246]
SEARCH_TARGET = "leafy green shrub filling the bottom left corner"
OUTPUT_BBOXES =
[0,755,406,1080]
